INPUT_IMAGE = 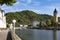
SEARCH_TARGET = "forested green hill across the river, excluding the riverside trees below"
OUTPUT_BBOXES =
[5,10,52,26]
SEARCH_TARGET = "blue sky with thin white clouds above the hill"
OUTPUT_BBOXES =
[0,0,60,17]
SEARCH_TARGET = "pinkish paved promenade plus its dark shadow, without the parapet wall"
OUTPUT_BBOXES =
[0,30,12,40]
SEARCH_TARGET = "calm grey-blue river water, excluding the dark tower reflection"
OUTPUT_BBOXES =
[16,29,60,40]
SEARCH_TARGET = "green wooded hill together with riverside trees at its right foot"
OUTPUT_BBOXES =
[5,10,60,27]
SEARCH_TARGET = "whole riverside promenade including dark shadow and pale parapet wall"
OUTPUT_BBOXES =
[0,29,21,40]
